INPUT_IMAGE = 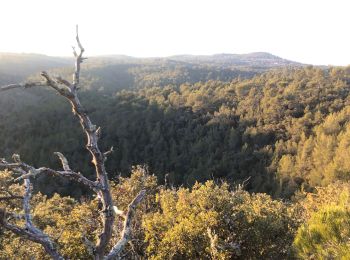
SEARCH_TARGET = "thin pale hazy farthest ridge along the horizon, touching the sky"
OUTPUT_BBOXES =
[0,52,304,76]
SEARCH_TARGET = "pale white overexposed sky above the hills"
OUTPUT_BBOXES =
[0,0,350,65]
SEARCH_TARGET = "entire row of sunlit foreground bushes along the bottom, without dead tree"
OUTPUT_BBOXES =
[0,169,350,259]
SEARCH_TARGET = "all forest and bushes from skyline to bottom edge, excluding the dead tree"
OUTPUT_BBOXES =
[0,53,350,259]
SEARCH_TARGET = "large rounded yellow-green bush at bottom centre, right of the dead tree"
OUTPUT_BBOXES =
[143,181,298,259]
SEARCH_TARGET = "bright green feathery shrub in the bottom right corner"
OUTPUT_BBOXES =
[294,181,350,259]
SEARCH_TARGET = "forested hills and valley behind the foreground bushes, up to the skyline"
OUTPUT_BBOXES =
[4,53,350,197]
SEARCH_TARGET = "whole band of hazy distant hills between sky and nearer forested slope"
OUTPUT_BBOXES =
[0,52,303,93]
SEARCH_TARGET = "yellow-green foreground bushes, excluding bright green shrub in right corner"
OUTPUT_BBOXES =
[0,170,300,259]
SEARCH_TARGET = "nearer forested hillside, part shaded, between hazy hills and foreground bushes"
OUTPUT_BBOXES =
[0,62,350,197]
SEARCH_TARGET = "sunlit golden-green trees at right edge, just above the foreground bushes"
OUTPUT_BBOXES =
[278,107,350,193]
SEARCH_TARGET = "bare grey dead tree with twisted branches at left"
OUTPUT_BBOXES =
[0,26,146,260]
